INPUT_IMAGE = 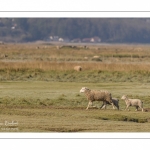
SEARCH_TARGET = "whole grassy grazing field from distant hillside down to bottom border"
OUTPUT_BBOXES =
[0,43,150,132]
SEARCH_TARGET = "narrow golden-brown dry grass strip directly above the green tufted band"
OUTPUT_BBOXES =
[0,61,150,72]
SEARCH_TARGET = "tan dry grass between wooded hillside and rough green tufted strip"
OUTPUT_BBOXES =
[0,44,150,71]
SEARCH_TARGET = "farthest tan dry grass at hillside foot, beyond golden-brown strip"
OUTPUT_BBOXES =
[0,43,150,60]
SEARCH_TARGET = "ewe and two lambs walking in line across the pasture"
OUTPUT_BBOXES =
[80,87,143,112]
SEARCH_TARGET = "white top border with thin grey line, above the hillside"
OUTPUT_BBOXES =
[0,0,150,17]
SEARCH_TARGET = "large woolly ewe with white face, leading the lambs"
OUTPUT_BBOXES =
[80,87,115,110]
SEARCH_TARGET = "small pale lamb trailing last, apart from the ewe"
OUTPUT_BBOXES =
[121,95,143,112]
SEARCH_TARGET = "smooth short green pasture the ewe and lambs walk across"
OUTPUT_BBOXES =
[0,81,150,132]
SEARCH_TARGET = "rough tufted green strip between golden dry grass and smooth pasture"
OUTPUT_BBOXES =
[0,69,150,83]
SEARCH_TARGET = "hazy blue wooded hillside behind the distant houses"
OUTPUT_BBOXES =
[0,18,150,43]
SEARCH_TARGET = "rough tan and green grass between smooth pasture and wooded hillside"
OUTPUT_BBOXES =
[0,43,150,83]
